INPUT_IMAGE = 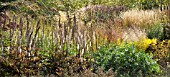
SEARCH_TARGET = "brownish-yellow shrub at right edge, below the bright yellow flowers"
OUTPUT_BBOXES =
[146,40,170,67]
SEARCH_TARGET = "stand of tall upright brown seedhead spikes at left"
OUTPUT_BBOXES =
[1,11,118,74]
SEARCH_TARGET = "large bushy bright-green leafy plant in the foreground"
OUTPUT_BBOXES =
[93,44,161,76]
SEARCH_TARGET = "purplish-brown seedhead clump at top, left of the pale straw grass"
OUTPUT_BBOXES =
[77,5,127,25]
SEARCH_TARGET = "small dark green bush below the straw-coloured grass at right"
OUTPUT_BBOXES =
[147,23,164,40]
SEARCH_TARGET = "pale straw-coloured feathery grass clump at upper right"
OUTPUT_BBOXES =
[121,9,161,28]
